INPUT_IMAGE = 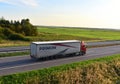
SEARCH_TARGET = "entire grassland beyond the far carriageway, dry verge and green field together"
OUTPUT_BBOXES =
[0,27,120,47]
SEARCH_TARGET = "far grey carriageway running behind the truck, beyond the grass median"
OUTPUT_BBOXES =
[0,41,120,53]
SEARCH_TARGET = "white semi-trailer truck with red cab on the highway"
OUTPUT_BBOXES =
[30,40,86,59]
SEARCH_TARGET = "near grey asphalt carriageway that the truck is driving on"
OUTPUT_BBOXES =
[0,45,120,76]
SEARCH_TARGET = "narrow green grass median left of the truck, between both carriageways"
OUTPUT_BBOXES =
[0,51,30,57]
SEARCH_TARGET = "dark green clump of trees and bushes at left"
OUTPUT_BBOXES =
[0,17,38,40]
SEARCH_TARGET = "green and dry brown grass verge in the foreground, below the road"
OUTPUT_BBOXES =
[0,54,120,84]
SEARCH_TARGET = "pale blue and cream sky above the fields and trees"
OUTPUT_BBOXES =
[0,0,120,29]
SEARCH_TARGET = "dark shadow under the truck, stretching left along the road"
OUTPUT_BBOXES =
[0,54,84,69]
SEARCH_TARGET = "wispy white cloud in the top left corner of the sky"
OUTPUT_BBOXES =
[0,0,38,7]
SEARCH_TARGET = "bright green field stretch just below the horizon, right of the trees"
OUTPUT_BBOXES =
[38,27,120,41]
